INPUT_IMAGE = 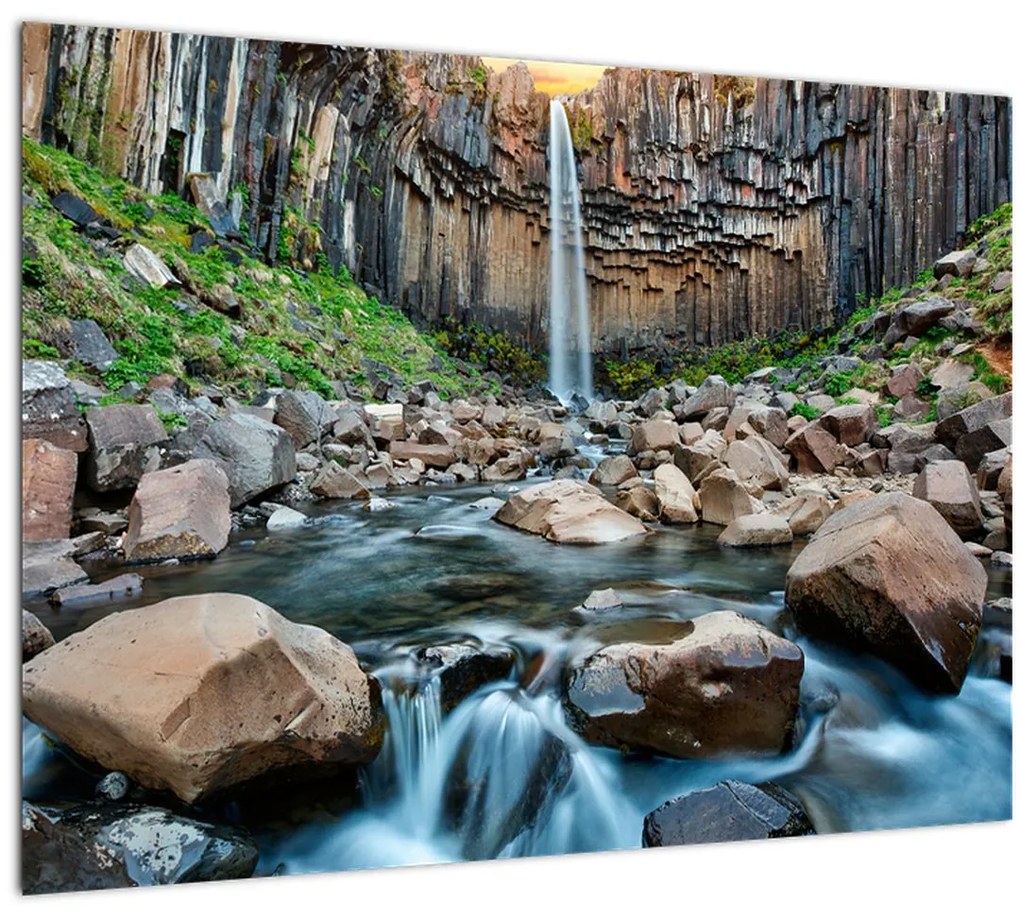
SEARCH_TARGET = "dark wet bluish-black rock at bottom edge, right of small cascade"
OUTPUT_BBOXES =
[642,781,815,848]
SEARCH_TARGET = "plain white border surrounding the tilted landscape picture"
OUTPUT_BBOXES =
[2,0,1020,918]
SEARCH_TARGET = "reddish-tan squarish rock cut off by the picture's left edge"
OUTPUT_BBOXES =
[21,440,78,542]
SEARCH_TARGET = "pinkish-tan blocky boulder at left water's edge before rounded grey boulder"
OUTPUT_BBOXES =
[123,459,231,561]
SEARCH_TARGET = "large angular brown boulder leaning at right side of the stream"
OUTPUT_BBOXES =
[786,493,987,693]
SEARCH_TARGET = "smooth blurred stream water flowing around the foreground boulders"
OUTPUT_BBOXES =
[23,459,1012,875]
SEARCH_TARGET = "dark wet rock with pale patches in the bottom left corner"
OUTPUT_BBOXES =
[21,802,258,895]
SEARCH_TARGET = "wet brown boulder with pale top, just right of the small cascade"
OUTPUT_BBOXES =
[565,611,804,758]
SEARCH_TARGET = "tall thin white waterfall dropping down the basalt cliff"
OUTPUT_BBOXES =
[549,99,592,404]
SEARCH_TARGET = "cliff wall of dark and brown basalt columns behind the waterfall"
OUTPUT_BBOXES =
[22,24,1012,354]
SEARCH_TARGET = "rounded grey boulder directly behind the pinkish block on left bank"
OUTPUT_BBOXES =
[195,414,298,507]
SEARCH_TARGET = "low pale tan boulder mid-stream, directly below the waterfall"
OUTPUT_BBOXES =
[493,479,646,545]
